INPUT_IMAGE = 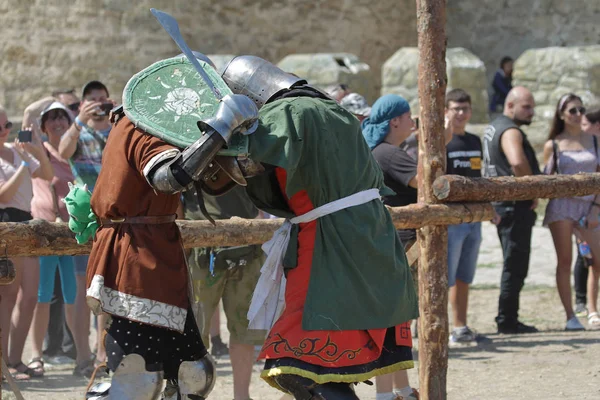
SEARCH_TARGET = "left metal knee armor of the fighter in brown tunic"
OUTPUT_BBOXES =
[108,354,163,400]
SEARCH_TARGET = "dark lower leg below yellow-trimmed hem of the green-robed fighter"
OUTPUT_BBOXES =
[275,375,359,400]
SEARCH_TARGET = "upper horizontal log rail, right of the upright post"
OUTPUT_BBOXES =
[433,173,600,202]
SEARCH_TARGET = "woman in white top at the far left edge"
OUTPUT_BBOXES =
[0,106,54,380]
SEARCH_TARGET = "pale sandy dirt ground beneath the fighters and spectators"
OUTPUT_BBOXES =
[2,220,600,400]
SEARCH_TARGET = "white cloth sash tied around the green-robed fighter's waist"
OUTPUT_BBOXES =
[247,189,381,330]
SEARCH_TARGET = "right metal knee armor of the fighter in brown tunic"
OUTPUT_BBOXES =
[178,354,216,400]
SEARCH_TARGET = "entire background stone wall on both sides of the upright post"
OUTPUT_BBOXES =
[0,0,600,129]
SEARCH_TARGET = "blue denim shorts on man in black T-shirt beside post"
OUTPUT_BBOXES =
[448,222,481,287]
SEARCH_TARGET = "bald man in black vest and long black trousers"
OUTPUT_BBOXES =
[483,87,541,333]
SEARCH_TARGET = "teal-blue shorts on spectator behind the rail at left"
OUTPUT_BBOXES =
[38,256,77,304]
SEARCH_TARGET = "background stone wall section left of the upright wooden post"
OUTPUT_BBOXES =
[0,0,417,116]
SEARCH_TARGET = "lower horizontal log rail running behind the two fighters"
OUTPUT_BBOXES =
[0,203,494,257]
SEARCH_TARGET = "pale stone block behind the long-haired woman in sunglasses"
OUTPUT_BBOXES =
[513,46,600,150]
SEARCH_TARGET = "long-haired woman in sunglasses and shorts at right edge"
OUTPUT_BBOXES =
[544,93,600,330]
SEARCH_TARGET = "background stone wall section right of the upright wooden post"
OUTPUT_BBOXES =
[446,0,600,82]
